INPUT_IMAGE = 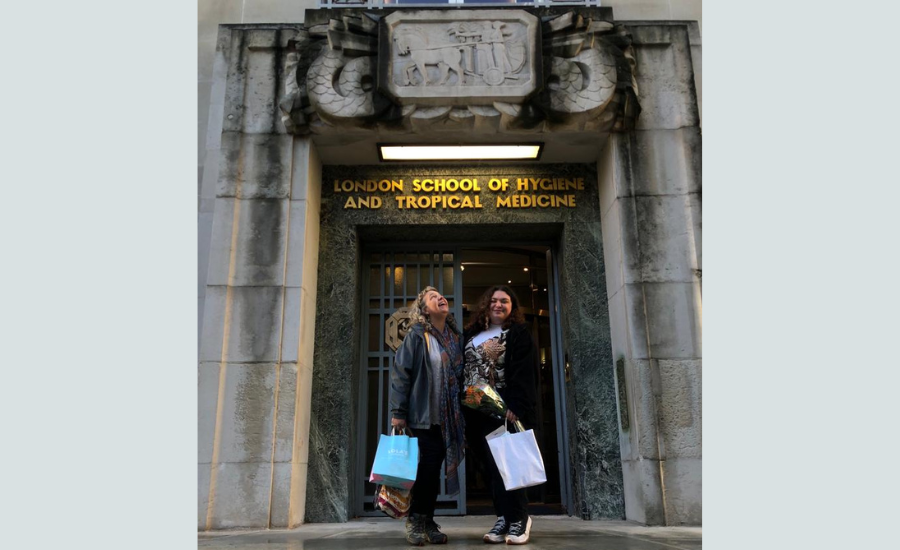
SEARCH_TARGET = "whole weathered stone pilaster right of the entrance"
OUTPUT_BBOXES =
[598,23,702,525]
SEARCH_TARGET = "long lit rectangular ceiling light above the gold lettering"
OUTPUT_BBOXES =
[378,143,544,162]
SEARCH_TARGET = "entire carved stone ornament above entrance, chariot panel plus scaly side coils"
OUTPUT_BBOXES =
[280,9,640,134]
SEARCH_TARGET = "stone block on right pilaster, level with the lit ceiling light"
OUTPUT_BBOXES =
[630,127,702,195]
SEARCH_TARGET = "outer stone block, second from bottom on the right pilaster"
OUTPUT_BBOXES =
[657,359,703,460]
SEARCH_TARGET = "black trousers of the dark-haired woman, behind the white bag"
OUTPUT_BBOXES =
[463,407,528,523]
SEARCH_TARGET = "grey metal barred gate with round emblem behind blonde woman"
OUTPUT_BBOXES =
[353,246,466,516]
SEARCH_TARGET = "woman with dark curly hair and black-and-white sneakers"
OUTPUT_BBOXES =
[463,285,537,544]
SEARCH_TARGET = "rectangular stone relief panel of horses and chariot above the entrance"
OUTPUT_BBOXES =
[378,10,542,106]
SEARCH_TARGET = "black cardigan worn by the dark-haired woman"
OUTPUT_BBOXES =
[463,323,538,426]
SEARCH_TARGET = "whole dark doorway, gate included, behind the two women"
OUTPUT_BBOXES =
[355,244,570,516]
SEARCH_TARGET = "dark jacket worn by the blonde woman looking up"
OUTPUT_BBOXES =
[389,324,462,430]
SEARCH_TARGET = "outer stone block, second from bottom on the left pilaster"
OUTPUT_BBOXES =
[219,363,277,462]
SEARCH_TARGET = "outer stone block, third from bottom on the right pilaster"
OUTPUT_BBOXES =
[644,283,702,359]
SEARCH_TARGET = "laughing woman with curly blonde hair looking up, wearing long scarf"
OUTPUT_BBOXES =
[390,286,465,546]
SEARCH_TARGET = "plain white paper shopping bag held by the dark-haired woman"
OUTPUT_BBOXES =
[485,424,547,491]
